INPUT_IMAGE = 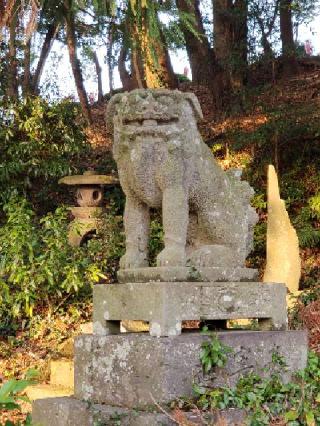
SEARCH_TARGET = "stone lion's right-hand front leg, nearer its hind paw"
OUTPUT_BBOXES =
[157,186,189,266]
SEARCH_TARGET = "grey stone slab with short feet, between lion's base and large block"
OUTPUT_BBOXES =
[93,282,287,337]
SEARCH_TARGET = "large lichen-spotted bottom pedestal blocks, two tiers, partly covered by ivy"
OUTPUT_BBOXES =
[33,331,307,426]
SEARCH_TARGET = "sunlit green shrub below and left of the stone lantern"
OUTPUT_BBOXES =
[0,195,104,328]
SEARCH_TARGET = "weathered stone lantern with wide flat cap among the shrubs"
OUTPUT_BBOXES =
[59,170,119,247]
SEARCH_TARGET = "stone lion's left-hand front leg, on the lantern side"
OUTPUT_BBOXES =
[120,195,150,269]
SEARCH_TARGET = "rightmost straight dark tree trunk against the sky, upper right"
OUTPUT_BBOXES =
[280,0,298,76]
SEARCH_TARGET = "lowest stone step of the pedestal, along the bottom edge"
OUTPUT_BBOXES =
[32,398,245,426]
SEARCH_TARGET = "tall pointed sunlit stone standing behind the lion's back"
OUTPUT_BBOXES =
[263,166,301,293]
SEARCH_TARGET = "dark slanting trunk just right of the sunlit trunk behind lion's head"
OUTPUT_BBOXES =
[177,0,215,87]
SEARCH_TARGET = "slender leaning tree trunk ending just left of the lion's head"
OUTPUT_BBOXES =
[64,0,92,124]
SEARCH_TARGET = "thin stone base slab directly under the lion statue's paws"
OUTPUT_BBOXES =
[118,266,258,283]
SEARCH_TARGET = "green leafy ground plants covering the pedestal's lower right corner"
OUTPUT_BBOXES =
[194,346,320,426]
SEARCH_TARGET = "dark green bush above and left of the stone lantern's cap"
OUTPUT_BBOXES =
[0,98,86,202]
